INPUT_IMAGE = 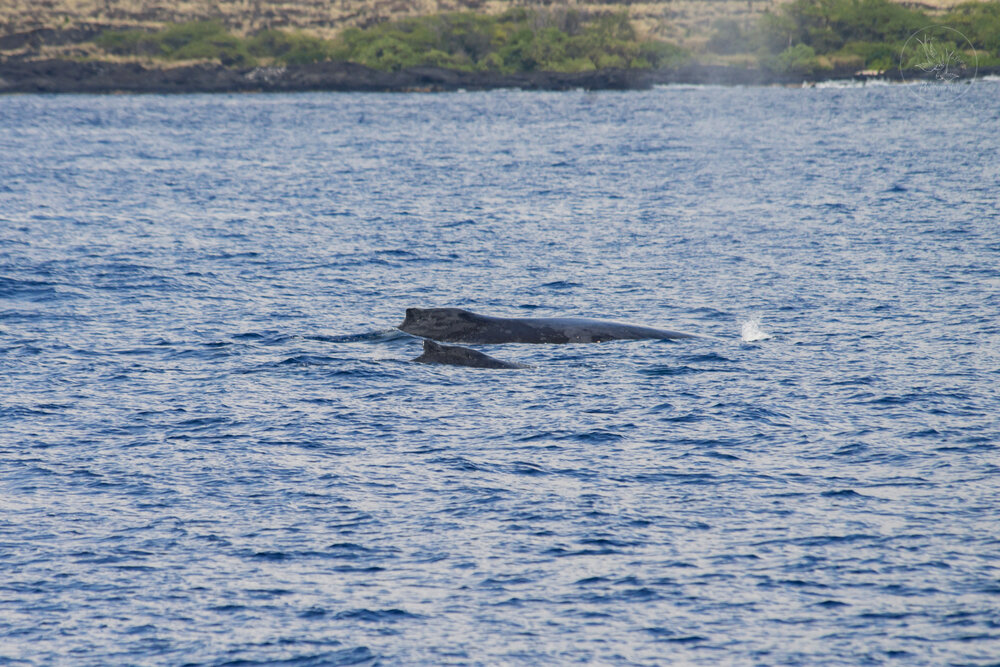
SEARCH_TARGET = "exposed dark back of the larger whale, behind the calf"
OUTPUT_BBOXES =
[399,308,695,345]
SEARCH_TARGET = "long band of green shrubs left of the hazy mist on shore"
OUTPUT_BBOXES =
[95,8,687,72]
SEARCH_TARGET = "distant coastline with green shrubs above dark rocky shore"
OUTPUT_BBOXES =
[0,0,1000,94]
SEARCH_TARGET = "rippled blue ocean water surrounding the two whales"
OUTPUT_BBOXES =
[0,81,1000,665]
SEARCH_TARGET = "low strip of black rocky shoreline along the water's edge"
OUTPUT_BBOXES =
[0,59,996,94]
